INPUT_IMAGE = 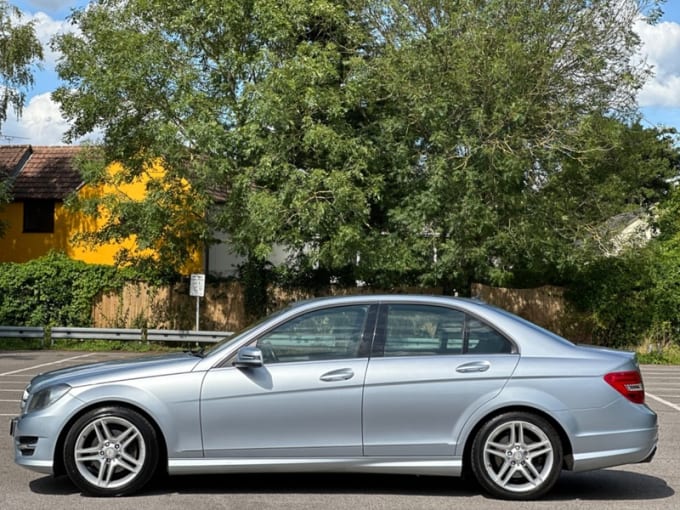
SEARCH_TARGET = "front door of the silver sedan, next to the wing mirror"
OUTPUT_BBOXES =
[201,304,376,458]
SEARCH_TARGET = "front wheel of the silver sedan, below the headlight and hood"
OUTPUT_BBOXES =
[63,406,158,496]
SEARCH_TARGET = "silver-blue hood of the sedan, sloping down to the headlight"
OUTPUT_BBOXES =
[29,353,200,392]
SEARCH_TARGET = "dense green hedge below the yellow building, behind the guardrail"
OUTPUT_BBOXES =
[0,252,125,327]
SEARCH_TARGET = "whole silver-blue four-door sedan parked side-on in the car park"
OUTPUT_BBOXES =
[12,296,658,499]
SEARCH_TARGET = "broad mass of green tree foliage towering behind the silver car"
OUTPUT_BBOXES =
[54,0,672,292]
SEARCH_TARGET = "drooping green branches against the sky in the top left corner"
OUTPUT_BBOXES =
[0,0,43,128]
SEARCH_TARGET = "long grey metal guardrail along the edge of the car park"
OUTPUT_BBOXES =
[0,326,233,343]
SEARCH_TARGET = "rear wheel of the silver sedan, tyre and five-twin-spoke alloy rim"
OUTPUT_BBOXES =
[470,412,563,500]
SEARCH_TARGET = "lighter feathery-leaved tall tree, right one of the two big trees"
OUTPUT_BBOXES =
[362,0,668,292]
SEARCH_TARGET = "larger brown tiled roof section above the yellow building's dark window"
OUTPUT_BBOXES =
[12,146,83,200]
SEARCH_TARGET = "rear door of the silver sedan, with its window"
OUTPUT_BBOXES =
[364,304,519,458]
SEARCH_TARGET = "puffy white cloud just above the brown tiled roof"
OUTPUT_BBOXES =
[2,94,69,145]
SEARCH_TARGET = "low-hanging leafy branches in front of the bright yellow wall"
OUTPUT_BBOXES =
[67,147,208,282]
